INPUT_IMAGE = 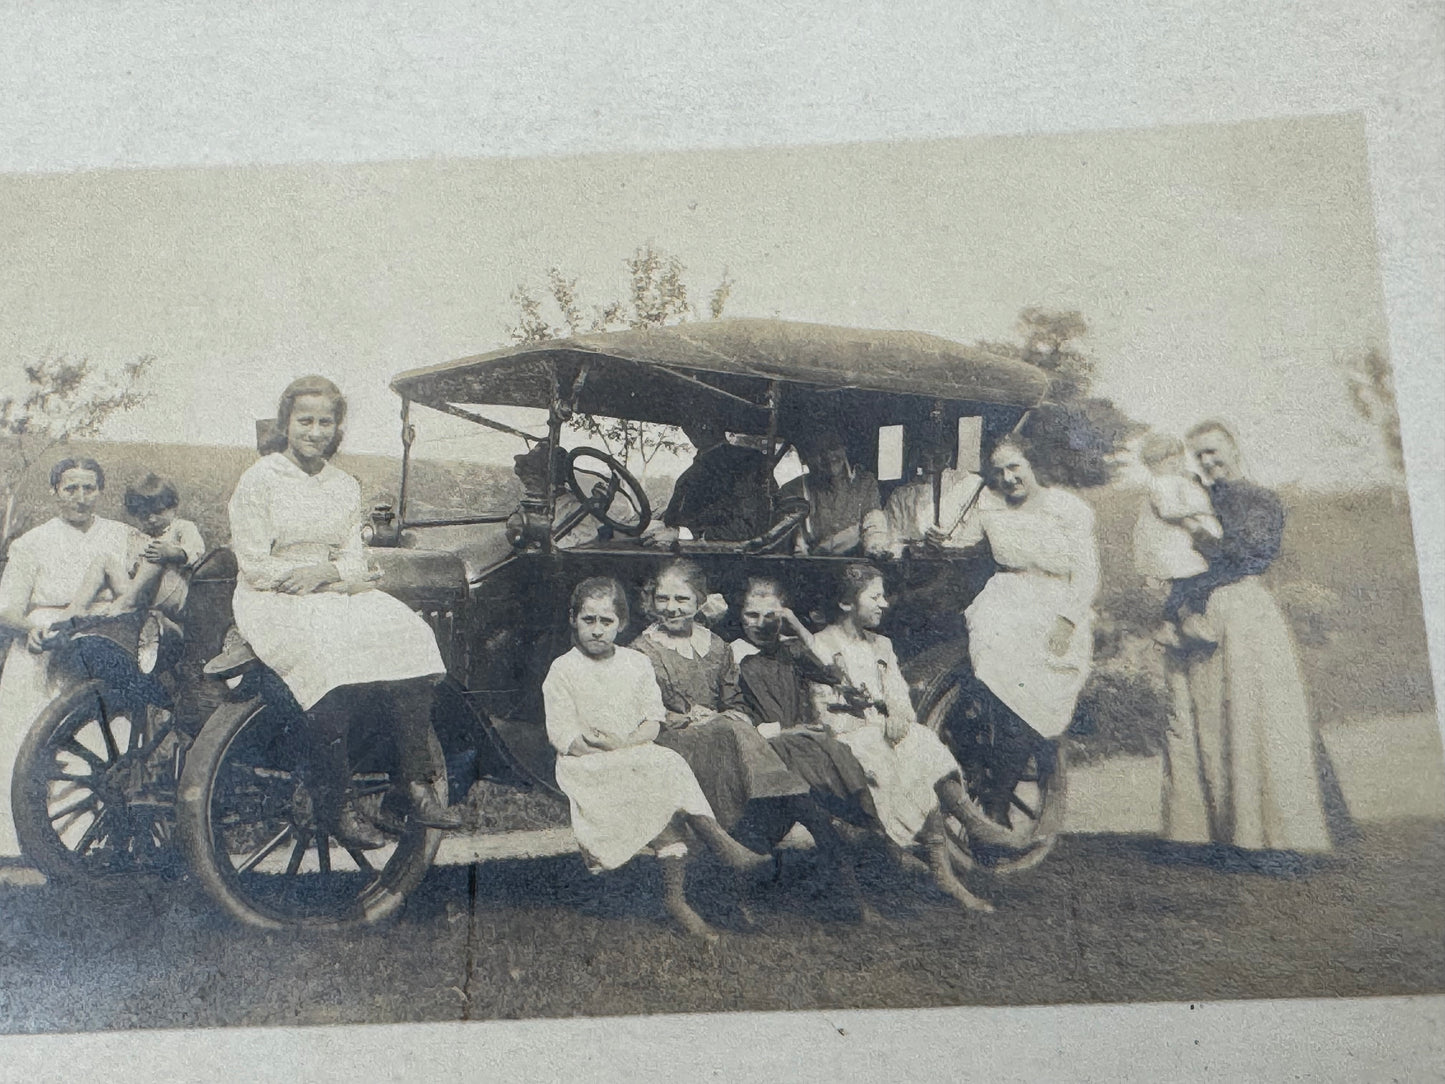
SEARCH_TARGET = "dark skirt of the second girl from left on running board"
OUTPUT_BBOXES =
[657,715,808,828]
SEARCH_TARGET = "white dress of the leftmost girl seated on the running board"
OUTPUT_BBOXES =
[542,648,712,873]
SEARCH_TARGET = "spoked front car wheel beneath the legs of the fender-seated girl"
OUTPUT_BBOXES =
[178,698,447,929]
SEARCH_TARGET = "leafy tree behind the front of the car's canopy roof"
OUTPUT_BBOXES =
[507,241,733,468]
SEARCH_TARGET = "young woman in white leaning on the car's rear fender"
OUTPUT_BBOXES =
[929,438,1100,824]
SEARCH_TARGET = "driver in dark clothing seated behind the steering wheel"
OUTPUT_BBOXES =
[644,421,773,548]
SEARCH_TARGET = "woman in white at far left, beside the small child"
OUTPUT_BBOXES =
[0,458,137,857]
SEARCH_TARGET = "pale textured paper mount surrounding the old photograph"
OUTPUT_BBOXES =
[0,0,1445,1081]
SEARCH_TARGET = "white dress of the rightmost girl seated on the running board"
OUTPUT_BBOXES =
[812,624,958,847]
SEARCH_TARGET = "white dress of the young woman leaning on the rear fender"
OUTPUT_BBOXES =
[949,487,1100,739]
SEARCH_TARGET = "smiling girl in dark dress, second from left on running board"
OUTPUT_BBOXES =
[631,559,808,830]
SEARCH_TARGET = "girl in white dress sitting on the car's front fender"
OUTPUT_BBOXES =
[228,376,461,847]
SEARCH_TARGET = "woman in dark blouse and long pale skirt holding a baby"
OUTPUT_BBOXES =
[1165,421,1331,851]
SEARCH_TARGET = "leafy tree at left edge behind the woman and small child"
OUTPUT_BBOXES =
[0,354,155,551]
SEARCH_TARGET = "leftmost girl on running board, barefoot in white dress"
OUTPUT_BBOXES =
[542,577,767,939]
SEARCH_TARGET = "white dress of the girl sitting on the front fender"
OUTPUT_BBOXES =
[230,452,445,710]
